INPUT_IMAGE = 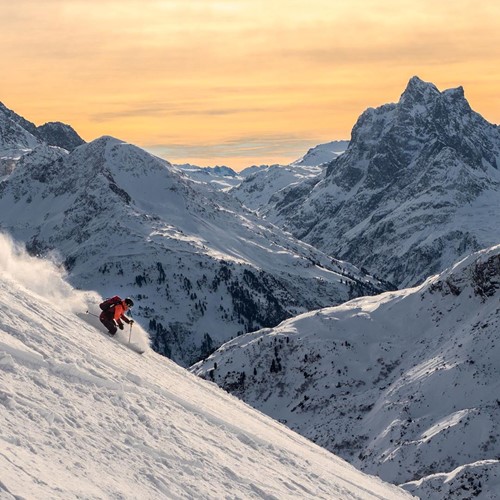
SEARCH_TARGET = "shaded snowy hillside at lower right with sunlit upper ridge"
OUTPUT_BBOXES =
[192,245,500,500]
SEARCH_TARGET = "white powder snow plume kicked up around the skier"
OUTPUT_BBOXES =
[0,233,149,349]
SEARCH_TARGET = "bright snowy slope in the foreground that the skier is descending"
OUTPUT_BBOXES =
[0,233,410,500]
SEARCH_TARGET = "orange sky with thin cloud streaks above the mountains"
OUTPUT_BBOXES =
[0,0,500,169]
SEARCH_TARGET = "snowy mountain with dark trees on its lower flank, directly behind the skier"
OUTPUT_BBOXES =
[0,137,387,365]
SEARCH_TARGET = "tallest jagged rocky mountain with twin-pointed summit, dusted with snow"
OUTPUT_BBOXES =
[262,77,500,286]
